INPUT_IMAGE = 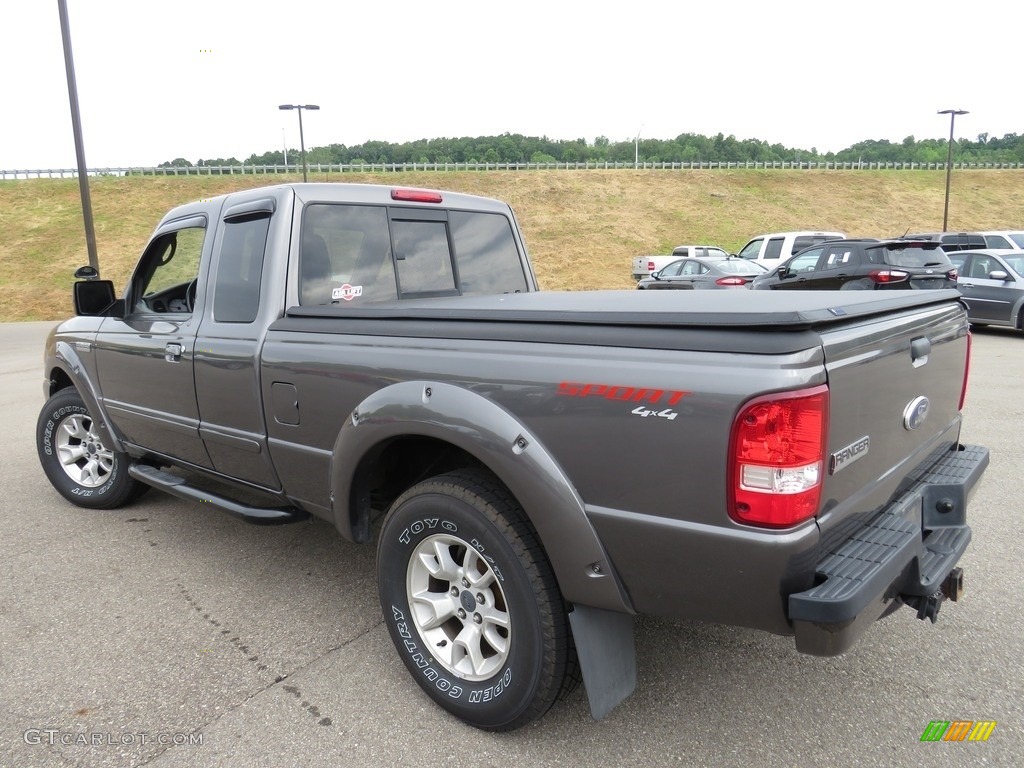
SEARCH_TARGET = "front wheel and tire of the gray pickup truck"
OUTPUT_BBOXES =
[36,389,148,509]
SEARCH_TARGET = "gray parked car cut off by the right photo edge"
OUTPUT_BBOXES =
[949,250,1024,331]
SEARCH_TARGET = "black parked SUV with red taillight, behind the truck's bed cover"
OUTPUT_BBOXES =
[751,238,956,291]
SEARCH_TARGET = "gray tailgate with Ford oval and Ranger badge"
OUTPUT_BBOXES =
[818,296,969,550]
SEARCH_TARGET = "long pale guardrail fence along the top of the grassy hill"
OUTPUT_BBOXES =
[0,161,1024,179]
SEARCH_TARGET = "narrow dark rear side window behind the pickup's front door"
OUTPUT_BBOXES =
[213,216,270,323]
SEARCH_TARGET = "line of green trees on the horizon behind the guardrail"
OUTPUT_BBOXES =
[159,133,1024,168]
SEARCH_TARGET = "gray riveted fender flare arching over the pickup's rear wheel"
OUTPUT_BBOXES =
[331,381,635,614]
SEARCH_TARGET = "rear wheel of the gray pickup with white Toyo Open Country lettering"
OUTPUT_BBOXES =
[377,471,575,731]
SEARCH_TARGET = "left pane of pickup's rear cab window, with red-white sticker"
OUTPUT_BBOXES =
[299,203,398,306]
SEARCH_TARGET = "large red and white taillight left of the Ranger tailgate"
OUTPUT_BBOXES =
[729,385,828,528]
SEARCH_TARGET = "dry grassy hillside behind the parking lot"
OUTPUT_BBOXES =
[0,170,1024,322]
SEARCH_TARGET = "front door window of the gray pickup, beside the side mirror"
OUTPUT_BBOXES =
[132,226,206,314]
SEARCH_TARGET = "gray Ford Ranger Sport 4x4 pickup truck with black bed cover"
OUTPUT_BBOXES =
[37,184,988,730]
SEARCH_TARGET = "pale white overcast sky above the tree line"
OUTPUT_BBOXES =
[0,0,1024,170]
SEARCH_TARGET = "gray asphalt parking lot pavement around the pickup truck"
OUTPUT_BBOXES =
[0,324,1024,768]
